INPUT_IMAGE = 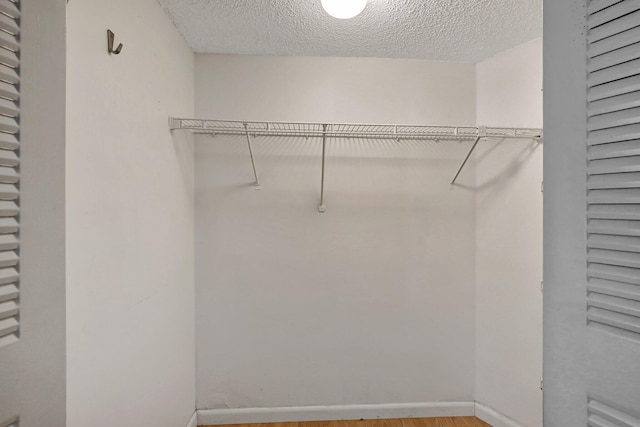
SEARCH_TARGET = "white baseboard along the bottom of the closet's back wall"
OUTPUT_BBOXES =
[198,402,475,425]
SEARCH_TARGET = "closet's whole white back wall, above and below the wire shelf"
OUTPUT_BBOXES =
[196,55,475,409]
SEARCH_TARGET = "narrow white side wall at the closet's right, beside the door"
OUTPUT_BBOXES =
[476,40,543,427]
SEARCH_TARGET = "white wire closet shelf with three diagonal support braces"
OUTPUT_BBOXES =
[169,117,543,212]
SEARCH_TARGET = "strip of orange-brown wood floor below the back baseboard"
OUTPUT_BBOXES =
[200,417,491,427]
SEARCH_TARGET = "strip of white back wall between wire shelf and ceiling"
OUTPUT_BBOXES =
[196,54,475,126]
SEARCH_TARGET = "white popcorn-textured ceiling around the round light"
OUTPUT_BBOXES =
[159,0,540,62]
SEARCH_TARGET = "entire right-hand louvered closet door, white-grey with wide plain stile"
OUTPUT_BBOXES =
[544,0,640,427]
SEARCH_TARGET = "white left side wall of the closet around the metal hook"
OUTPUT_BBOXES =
[66,0,195,427]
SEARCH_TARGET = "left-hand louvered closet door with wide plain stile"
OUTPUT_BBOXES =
[0,0,66,427]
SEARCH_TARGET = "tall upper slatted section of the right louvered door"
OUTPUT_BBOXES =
[587,0,640,344]
